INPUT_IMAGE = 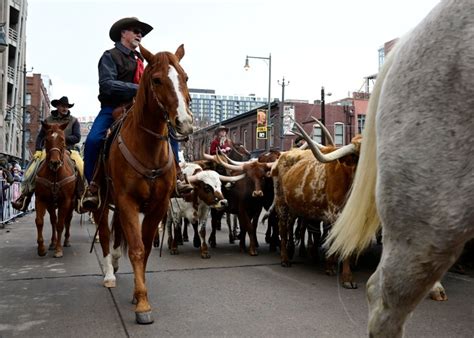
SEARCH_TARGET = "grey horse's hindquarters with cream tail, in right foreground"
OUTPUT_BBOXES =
[328,0,474,337]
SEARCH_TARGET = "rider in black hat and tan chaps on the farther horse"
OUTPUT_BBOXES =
[12,96,84,211]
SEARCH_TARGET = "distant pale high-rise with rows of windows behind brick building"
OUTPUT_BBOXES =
[189,88,268,128]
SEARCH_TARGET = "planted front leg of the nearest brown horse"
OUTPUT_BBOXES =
[117,202,154,324]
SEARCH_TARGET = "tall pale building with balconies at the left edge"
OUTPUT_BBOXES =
[0,0,27,158]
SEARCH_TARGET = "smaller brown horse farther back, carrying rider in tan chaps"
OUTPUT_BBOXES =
[35,122,77,258]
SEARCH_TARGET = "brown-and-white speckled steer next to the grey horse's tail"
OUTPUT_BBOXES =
[272,129,361,288]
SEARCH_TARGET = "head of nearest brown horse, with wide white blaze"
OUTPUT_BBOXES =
[137,45,193,135]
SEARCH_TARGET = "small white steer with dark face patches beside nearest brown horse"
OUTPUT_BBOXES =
[167,163,244,258]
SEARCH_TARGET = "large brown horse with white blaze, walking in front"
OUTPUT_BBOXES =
[94,45,193,324]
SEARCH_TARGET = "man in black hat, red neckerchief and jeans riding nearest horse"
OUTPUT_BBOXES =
[82,17,192,211]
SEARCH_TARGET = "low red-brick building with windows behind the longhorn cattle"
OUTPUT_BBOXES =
[184,98,368,161]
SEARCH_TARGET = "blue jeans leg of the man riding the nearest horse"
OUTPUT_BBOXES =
[84,107,115,183]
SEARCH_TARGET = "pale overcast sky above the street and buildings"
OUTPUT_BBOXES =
[26,0,439,116]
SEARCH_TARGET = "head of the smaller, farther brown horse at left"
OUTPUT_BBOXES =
[41,121,68,171]
